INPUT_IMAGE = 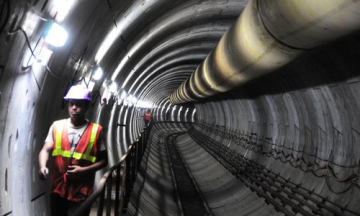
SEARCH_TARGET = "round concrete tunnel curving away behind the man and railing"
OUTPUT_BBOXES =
[0,0,360,216]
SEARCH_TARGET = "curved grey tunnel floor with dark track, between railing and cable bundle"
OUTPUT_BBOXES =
[127,123,283,215]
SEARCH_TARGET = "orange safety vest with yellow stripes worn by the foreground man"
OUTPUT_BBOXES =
[51,119,102,202]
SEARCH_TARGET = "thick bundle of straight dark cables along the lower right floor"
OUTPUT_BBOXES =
[189,129,360,215]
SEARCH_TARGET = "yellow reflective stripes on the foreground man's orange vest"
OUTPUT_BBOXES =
[52,121,99,163]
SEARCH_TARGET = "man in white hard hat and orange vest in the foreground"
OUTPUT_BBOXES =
[39,85,107,216]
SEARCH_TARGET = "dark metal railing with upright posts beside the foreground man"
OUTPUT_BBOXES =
[74,125,151,216]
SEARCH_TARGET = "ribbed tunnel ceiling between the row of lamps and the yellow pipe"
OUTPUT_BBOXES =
[50,0,247,107]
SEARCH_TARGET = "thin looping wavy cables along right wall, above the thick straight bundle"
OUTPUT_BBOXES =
[196,120,360,194]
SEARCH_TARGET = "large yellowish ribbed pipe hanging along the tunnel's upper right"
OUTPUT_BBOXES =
[170,0,360,104]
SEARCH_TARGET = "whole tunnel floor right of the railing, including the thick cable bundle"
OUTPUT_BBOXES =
[121,122,358,215]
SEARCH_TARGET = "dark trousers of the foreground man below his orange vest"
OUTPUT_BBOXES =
[50,194,90,216]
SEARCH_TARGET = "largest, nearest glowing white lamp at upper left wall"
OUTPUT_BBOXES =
[44,21,68,47]
